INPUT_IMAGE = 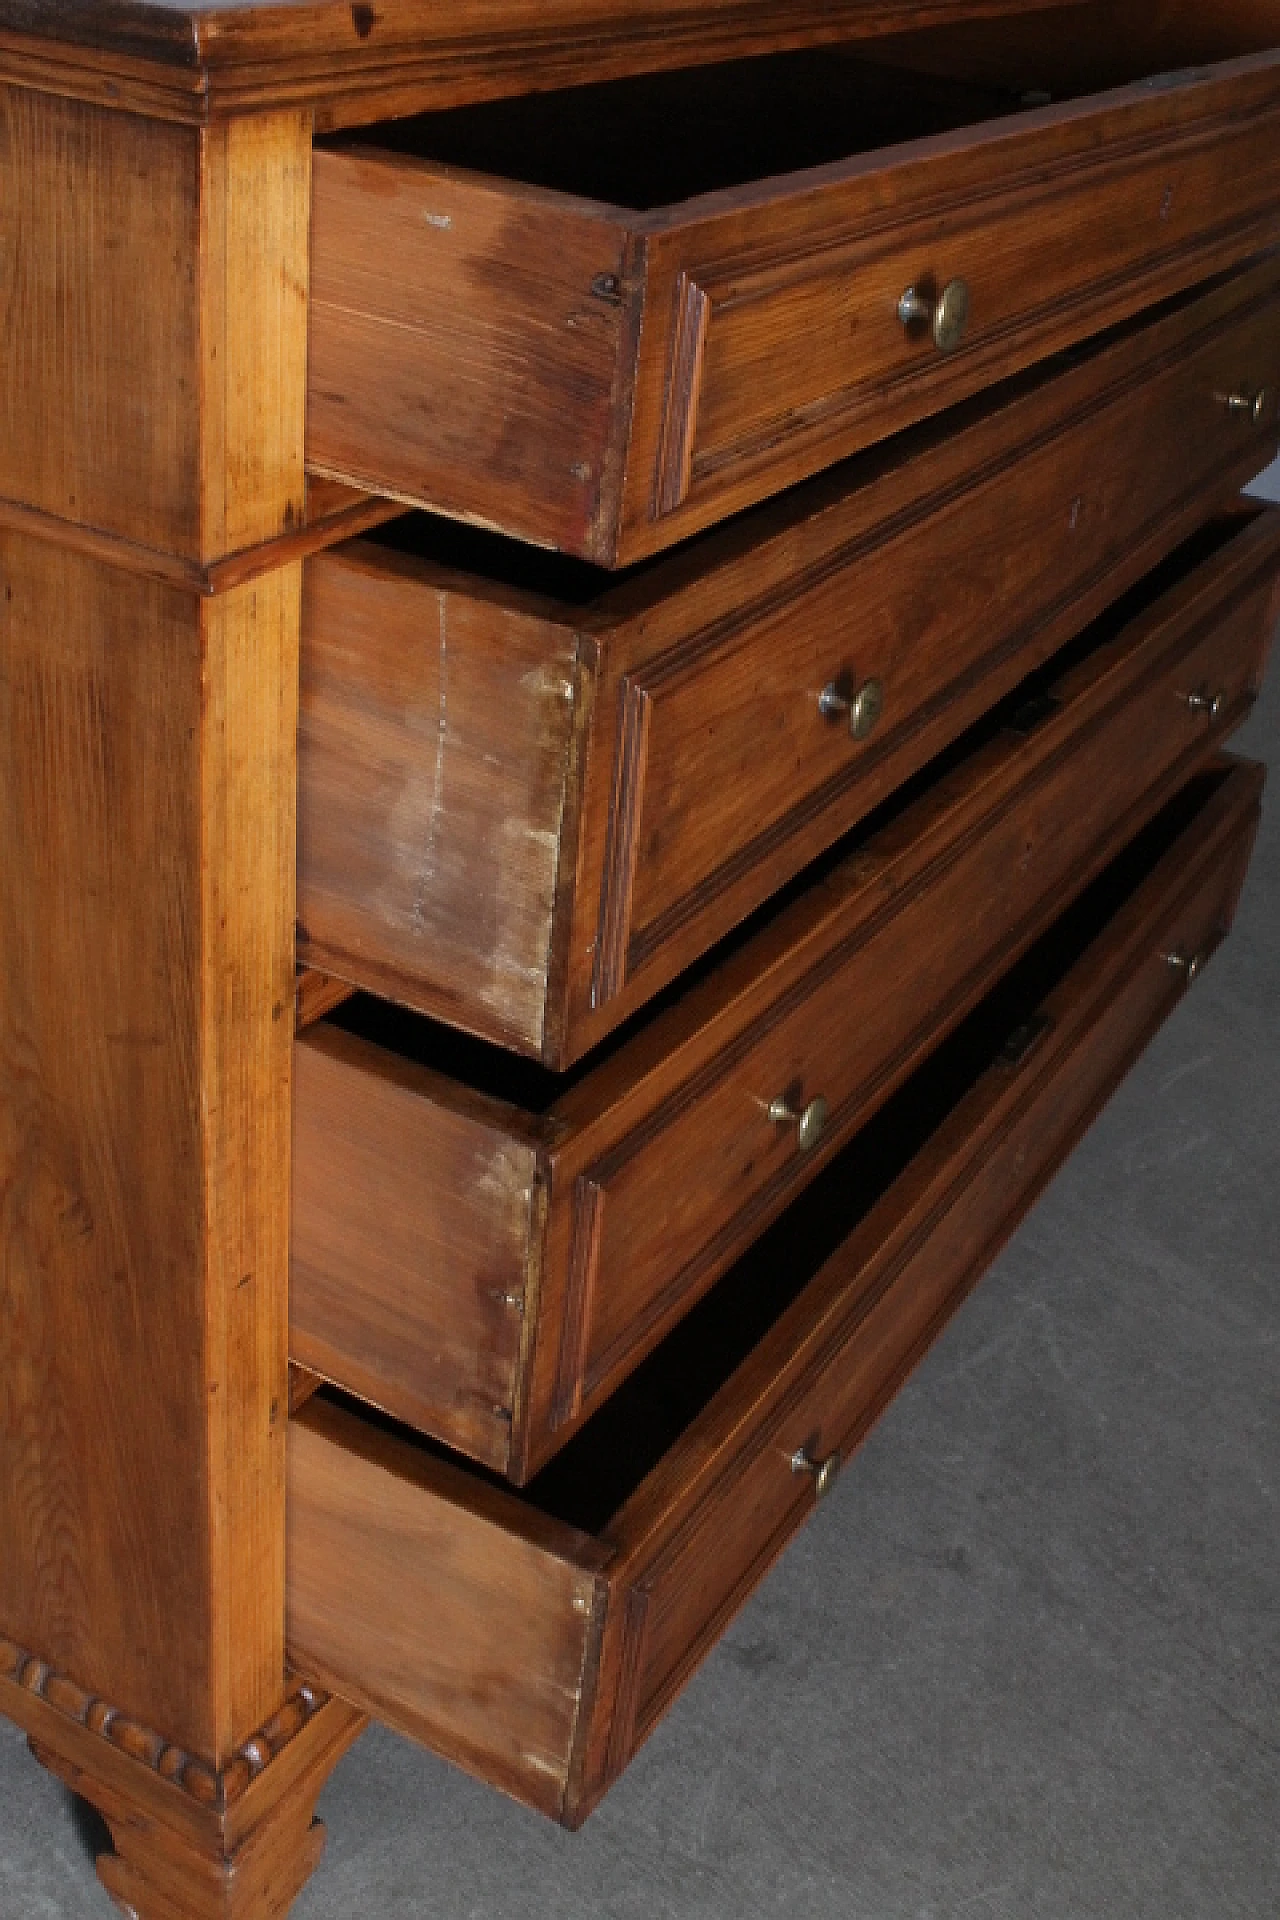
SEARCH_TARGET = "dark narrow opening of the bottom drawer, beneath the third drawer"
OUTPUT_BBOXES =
[305,762,1230,1536]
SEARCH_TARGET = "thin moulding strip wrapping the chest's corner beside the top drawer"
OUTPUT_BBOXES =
[0,487,405,599]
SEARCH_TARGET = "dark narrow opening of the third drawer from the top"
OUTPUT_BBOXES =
[318,505,1263,1117]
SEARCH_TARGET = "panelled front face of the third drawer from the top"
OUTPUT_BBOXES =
[553,524,1276,1423]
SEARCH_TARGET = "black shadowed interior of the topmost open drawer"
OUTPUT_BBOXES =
[326,0,1280,211]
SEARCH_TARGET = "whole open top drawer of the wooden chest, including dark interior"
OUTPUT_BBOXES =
[309,0,1280,566]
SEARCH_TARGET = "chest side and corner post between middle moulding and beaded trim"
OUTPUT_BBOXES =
[0,534,297,1763]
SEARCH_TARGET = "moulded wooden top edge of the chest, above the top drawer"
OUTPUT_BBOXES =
[0,0,1082,127]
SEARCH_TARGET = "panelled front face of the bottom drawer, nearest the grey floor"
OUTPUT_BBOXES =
[597,756,1253,1788]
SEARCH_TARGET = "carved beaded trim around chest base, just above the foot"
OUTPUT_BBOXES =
[0,1636,330,1812]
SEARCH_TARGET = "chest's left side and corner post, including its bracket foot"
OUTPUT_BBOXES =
[0,83,361,1920]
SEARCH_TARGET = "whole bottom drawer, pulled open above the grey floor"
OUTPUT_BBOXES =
[288,758,1263,1826]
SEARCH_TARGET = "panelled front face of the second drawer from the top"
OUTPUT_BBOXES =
[595,275,1280,1002]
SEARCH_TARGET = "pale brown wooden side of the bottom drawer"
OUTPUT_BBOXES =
[290,1402,604,1814]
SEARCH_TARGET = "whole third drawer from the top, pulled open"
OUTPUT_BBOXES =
[290,513,1280,1482]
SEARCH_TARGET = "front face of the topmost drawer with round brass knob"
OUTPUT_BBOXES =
[633,72,1280,545]
